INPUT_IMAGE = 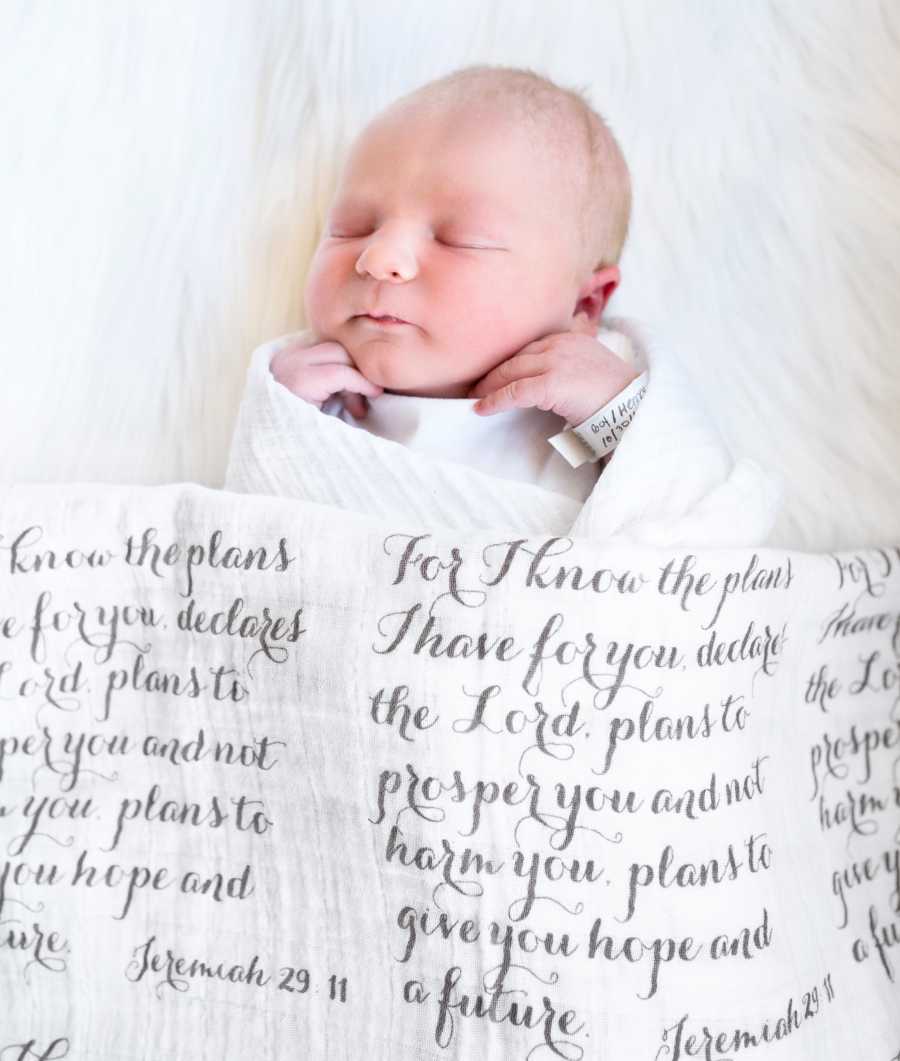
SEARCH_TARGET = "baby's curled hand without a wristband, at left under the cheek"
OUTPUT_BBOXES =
[269,340,383,420]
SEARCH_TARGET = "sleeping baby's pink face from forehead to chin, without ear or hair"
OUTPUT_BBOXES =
[306,107,583,398]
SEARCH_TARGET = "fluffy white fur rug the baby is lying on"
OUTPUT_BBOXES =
[0,0,900,549]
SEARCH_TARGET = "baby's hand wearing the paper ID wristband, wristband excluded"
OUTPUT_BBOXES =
[467,332,639,424]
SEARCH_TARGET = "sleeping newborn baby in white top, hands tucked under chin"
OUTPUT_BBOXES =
[270,67,638,501]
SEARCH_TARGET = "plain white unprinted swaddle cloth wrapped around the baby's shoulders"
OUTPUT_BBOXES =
[225,319,779,546]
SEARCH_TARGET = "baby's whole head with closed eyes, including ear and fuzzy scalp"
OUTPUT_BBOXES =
[306,67,630,398]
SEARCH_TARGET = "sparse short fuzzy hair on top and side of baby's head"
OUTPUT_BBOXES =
[388,65,631,272]
